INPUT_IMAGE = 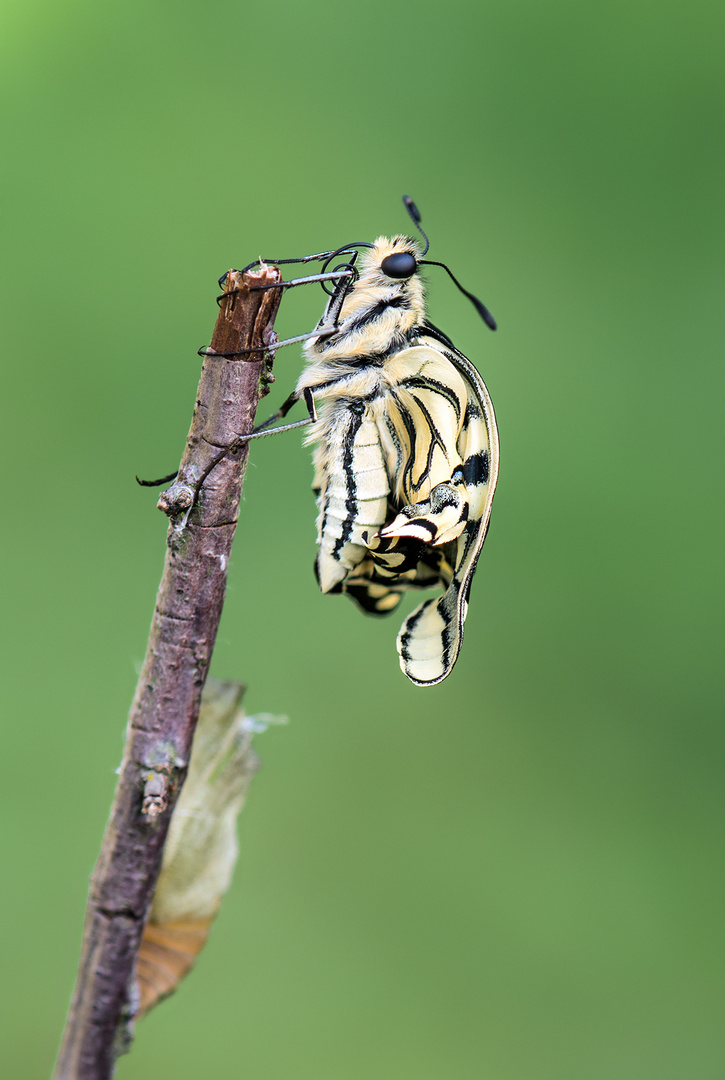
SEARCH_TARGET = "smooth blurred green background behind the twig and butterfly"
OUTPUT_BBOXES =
[0,0,725,1080]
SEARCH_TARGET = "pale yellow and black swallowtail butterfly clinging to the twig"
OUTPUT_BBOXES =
[247,197,499,686]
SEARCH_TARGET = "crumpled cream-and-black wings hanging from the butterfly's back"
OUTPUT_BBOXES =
[366,327,499,686]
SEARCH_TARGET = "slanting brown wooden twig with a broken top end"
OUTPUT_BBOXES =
[55,267,282,1080]
